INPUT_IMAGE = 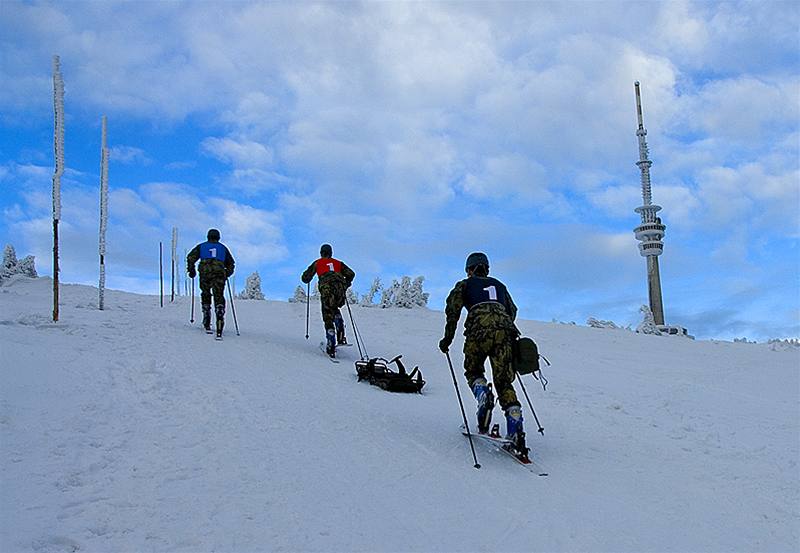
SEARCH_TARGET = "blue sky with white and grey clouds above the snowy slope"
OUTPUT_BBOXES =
[0,0,800,340]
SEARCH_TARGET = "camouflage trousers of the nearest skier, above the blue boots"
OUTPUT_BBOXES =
[464,329,520,409]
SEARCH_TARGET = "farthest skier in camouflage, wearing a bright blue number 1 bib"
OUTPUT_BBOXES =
[186,228,236,338]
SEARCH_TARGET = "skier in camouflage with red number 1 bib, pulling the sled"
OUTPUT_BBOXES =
[300,244,356,357]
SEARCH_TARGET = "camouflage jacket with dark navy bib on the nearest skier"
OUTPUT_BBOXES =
[444,276,519,341]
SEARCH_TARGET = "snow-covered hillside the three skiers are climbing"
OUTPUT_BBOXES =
[0,278,800,552]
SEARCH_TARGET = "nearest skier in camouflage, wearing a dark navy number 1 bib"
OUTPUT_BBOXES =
[439,252,522,438]
